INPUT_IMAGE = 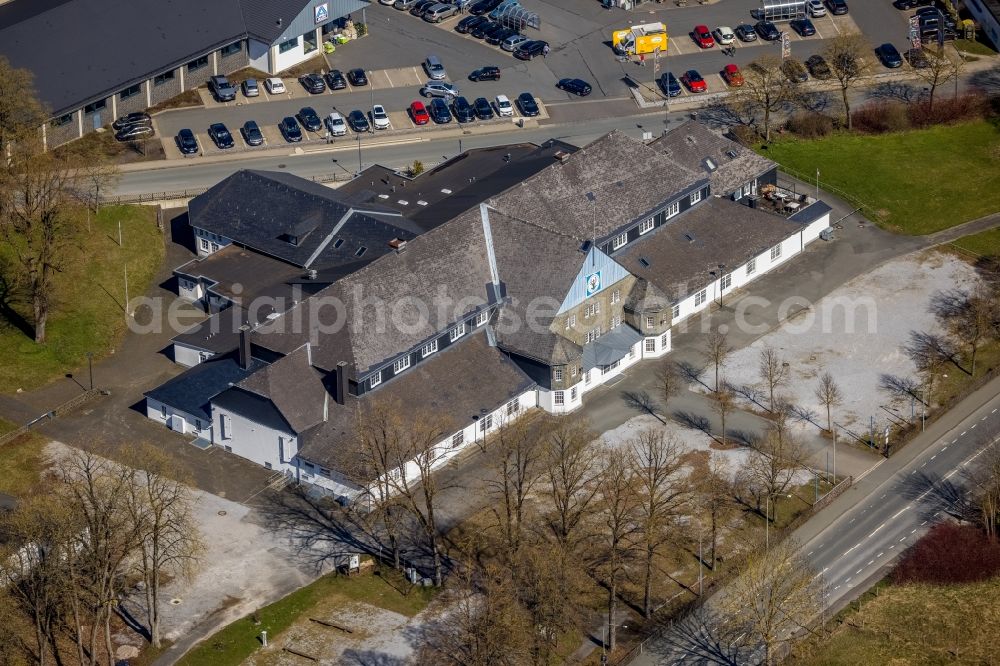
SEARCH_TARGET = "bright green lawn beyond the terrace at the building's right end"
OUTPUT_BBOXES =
[761,121,1000,235]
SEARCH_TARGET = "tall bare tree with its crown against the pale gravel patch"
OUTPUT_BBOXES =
[628,428,691,619]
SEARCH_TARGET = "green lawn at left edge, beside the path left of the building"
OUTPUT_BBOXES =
[0,206,164,393]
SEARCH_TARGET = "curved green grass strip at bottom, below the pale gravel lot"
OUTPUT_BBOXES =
[178,568,436,666]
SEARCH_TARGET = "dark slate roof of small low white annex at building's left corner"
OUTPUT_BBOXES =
[145,354,265,421]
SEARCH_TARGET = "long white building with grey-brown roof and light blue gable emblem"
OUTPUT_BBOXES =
[141,127,830,499]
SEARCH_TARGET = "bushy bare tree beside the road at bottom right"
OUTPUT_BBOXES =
[721,539,822,666]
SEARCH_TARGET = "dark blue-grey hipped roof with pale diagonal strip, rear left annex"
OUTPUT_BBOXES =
[188,170,421,274]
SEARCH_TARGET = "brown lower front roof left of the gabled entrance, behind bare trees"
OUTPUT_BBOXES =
[299,330,534,484]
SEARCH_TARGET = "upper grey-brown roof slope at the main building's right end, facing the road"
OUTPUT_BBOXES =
[490,130,707,240]
